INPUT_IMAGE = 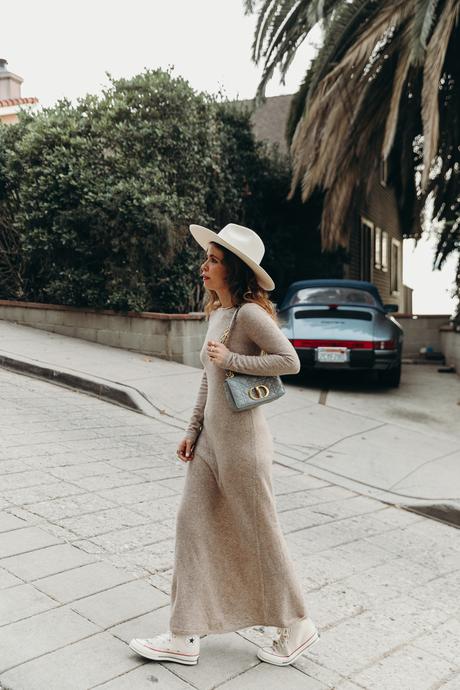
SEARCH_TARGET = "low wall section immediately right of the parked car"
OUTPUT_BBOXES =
[393,313,450,357]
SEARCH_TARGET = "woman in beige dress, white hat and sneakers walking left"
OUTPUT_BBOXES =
[130,223,318,666]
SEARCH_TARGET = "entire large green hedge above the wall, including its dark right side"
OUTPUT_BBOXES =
[0,70,343,312]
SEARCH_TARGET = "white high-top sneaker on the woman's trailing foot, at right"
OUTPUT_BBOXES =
[257,617,319,666]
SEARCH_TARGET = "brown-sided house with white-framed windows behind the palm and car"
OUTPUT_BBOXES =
[241,95,412,314]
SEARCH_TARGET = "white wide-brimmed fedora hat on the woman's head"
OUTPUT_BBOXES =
[190,223,275,290]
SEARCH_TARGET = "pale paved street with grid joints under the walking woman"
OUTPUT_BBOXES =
[0,362,460,690]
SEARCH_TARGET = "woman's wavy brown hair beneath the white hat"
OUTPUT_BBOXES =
[204,242,278,323]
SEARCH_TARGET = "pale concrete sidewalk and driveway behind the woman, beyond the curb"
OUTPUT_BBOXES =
[0,321,460,508]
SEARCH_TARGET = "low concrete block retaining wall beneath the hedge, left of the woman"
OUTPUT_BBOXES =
[0,300,208,368]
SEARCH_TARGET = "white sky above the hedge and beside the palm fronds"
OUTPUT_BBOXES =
[0,0,456,314]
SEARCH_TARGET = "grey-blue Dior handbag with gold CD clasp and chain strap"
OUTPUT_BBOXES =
[220,307,286,412]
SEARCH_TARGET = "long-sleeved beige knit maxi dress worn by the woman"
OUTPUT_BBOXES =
[170,303,307,635]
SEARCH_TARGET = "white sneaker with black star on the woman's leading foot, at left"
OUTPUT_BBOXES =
[129,632,200,666]
